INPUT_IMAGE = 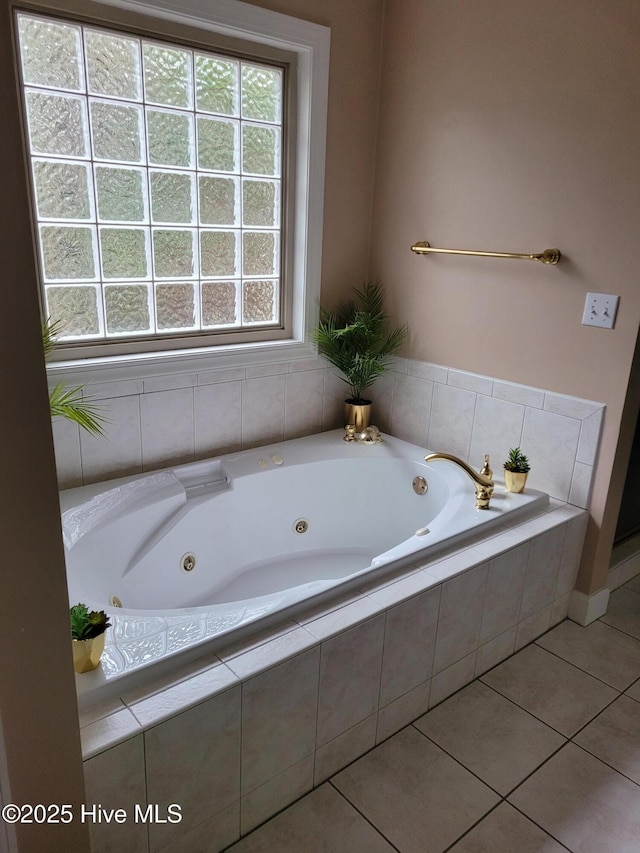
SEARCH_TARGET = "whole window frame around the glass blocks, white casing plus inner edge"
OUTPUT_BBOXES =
[14,0,330,382]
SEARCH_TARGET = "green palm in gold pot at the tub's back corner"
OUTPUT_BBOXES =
[313,282,409,432]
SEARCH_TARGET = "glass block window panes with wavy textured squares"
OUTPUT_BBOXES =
[16,12,285,344]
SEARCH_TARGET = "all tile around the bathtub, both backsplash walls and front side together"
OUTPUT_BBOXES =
[66,359,604,853]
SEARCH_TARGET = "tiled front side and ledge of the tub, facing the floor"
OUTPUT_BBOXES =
[81,501,587,853]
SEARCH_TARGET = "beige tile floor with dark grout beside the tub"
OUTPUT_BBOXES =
[229,578,640,853]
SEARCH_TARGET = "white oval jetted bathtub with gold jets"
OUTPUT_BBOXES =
[60,430,548,704]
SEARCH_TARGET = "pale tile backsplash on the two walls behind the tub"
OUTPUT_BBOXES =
[54,359,604,507]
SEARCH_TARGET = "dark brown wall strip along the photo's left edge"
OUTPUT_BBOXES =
[0,3,88,853]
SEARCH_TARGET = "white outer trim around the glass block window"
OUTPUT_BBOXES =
[16,0,330,382]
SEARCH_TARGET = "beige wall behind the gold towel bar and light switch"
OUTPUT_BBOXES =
[370,0,640,592]
